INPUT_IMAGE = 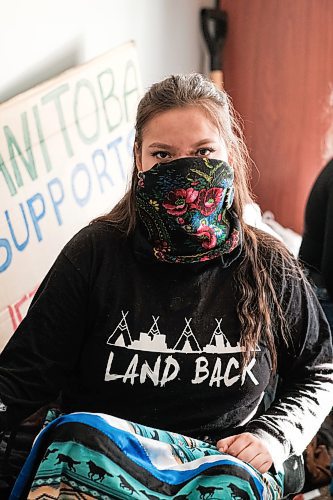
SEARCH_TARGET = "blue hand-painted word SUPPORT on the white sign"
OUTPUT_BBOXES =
[0,130,134,273]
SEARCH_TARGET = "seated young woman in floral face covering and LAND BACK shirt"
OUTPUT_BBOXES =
[0,74,333,499]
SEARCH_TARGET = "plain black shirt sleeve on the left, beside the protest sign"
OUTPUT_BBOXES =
[0,238,89,430]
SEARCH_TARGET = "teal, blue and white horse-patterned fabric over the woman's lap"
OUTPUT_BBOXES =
[10,413,283,500]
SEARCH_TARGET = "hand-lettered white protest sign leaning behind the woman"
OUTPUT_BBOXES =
[0,42,142,351]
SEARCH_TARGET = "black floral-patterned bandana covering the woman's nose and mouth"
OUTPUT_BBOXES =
[136,157,240,263]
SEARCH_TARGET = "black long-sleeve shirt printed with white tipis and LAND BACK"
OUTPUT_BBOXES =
[0,223,333,470]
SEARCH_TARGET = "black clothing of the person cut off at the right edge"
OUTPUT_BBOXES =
[299,159,333,301]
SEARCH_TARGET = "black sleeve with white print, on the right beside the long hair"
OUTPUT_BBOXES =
[246,272,333,468]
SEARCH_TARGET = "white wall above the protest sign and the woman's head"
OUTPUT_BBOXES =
[0,0,213,102]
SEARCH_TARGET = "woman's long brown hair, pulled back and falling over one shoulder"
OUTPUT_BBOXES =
[95,73,297,370]
